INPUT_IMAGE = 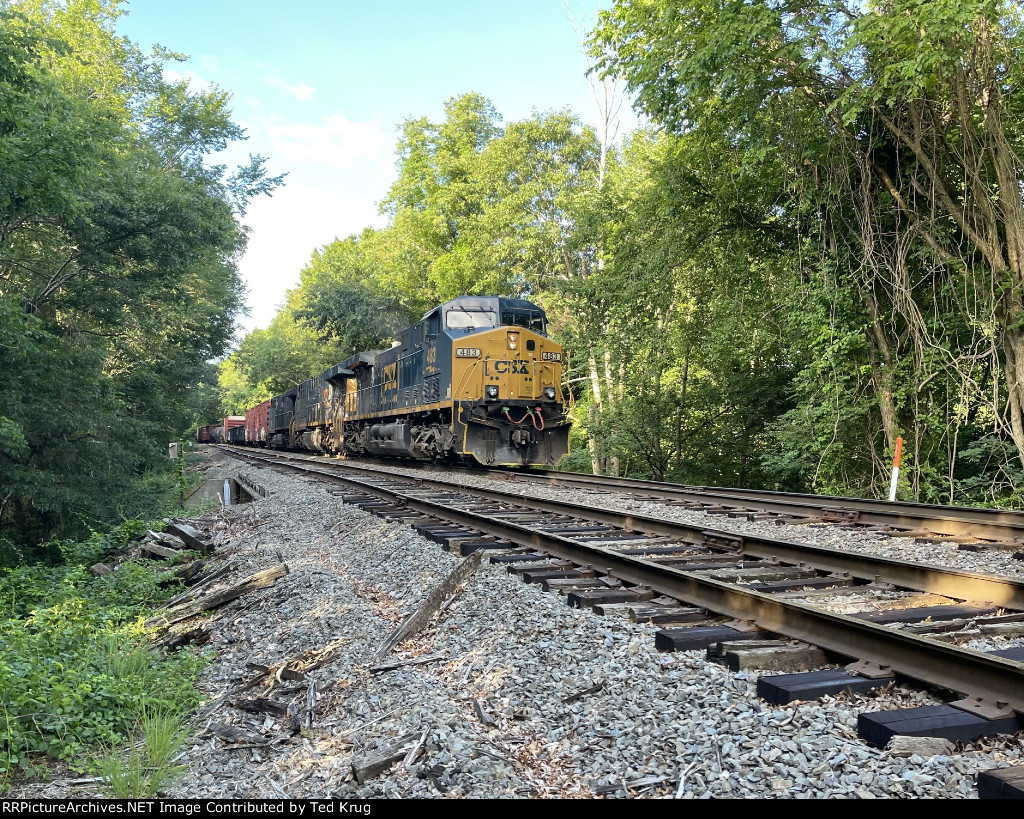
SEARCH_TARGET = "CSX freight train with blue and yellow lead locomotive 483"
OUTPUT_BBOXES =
[197,296,570,466]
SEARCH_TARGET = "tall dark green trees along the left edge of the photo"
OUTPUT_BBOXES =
[0,0,280,565]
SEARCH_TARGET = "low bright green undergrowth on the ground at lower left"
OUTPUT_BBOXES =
[0,524,199,789]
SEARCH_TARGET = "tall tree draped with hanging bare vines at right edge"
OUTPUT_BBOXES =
[594,0,1024,500]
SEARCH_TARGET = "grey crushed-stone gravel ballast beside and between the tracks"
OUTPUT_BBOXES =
[16,450,1022,799]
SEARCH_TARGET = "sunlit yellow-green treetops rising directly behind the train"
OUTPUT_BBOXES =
[220,94,598,413]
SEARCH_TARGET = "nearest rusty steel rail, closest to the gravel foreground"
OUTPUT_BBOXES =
[228,450,1024,713]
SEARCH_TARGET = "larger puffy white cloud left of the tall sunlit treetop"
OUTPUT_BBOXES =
[260,114,394,170]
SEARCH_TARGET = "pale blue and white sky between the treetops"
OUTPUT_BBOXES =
[112,0,610,331]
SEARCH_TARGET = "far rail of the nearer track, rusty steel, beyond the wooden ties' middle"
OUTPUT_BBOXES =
[236,450,1024,611]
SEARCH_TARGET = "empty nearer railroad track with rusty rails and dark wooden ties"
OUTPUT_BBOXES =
[222,450,1024,757]
